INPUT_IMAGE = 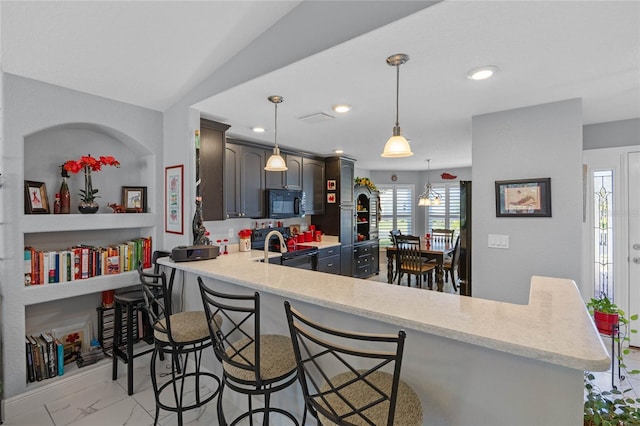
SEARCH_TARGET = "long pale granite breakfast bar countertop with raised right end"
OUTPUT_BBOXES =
[159,248,611,371]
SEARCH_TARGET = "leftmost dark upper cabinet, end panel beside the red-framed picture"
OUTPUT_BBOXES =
[201,119,230,220]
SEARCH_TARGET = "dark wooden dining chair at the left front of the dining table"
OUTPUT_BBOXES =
[396,235,438,288]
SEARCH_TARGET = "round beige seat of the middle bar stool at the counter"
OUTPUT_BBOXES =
[222,334,296,381]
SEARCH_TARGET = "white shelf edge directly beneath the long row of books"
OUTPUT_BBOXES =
[23,271,146,306]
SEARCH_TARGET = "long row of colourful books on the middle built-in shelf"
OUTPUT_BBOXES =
[24,237,152,286]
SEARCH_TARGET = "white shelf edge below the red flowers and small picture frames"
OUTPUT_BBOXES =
[20,213,156,234]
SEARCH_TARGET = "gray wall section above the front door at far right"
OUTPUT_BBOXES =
[583,118,640,149]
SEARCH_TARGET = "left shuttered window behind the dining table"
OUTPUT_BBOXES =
[378,185,415,247]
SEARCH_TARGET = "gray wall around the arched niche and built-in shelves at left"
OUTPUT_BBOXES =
[0,74,163,397]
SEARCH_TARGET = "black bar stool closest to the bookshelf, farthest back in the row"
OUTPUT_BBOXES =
[111,250,175,395]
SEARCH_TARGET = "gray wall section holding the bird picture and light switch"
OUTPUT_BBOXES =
[472,99,582,303]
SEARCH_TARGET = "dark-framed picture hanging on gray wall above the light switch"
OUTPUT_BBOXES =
[495,178,551,217]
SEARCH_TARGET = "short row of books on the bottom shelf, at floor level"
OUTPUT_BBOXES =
[25,333,65,382]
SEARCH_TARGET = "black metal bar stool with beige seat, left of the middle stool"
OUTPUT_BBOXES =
[138,268,222,426]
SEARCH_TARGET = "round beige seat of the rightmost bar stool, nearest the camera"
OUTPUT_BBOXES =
[318,370,422,426]
